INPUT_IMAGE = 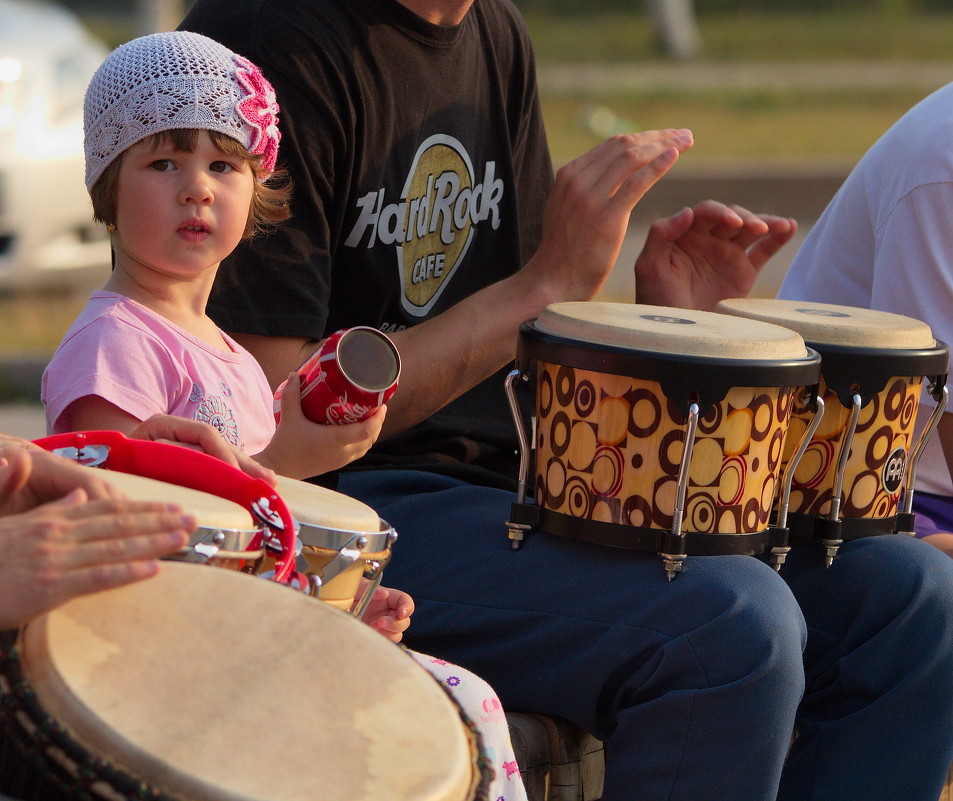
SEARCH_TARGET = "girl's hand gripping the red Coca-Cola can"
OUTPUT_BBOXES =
[255,373,387,479]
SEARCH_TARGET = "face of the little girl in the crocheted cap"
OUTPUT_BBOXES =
[113,131,255,280]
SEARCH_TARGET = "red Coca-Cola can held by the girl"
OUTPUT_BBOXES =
[274,325,400,425]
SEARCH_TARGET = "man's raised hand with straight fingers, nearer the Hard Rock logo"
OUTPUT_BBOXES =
[523,129,693,301]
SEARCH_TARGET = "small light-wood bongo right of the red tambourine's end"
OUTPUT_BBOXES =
[276,476,397,617]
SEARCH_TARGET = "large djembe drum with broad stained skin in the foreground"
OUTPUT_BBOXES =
[0,562,484,801]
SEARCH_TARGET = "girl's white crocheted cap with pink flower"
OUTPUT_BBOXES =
[83,31,281,189]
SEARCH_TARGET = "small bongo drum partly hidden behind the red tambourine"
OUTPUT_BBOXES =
[81,467,264,570]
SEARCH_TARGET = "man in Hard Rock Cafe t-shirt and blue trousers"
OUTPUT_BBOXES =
[182,0,953,801]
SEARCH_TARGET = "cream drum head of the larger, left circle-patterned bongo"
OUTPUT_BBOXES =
[535,302,807,361]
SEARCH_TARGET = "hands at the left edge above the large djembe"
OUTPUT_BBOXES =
[0,447,196,629]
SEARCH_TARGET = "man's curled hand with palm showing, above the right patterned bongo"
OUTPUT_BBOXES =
[635,200,797,311]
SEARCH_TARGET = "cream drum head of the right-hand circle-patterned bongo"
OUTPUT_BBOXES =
[716,298,936,350]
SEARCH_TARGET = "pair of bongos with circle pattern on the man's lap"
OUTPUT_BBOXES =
[506,300,948,579]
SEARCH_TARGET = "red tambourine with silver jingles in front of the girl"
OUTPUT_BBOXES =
[33,431,296,584]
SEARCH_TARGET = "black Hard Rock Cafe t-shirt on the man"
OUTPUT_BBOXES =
[180,0,553,485]
